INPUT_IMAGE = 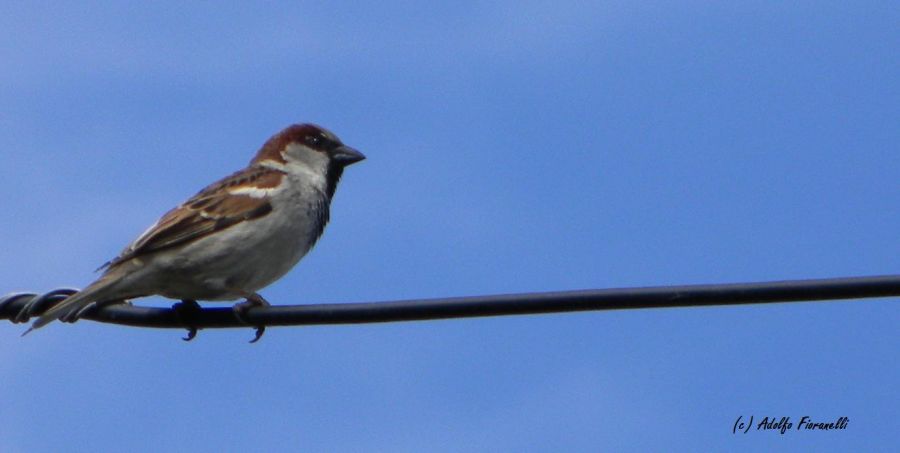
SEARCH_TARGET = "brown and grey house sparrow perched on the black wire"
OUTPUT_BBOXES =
[25,124,365,341]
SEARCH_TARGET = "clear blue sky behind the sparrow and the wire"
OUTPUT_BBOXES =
[0,1,900,452]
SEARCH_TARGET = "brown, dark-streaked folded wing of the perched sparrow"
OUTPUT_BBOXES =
[104,167,283,267]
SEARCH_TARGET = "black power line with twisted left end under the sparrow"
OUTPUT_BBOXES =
[0,275,900,338]
